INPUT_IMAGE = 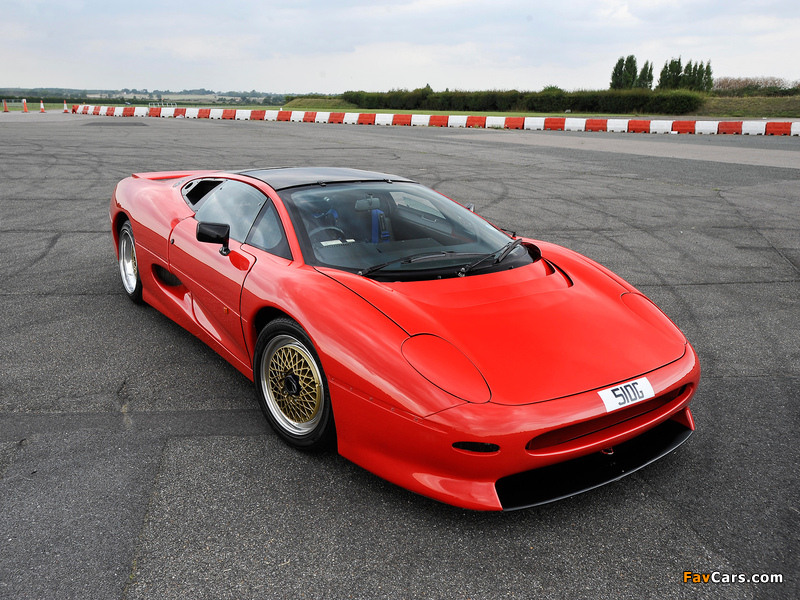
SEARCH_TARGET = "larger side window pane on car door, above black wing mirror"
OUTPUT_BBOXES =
[195,180,267,242]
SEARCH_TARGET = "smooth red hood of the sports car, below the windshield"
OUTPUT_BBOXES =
[320,242,686,404]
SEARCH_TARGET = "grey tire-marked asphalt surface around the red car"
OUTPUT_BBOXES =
[0,113,800,600]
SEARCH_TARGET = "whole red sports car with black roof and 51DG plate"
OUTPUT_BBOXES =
[111,168,700,510]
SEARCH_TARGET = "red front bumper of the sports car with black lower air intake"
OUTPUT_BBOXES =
[331,344,700,510]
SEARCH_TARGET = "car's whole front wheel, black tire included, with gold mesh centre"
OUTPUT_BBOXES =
[253,318,336,450]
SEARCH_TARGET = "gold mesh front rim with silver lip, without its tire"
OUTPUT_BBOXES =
[260,335,325,436]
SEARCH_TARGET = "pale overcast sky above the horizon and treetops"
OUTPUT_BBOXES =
[0,0,800,93]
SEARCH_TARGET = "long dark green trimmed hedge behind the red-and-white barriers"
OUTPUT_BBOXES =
[342,88,705,115]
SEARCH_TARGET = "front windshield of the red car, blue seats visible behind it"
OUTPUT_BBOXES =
[280,181,533,280]
